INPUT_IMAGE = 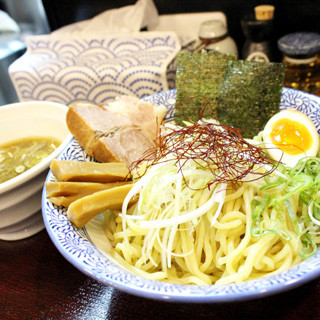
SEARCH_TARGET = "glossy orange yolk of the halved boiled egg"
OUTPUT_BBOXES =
[270,119,312,155]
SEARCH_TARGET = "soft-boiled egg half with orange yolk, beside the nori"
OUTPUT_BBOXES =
[263,109,319,167]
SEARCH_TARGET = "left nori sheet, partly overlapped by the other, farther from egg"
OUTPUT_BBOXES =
[175,51,235,125]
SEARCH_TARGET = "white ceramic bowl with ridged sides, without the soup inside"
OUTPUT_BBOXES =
[0,101,72,240]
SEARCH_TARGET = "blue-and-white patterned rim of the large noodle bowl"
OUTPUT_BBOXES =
[42,88,320,303]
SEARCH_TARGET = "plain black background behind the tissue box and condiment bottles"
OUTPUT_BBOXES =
[40,0,320,61]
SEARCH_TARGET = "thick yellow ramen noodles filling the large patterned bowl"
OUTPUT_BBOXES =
[104,162,319,285]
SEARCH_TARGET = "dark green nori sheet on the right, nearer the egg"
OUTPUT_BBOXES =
[216,60,285,138]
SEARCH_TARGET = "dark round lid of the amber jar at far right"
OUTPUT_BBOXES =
[278,32,320,56]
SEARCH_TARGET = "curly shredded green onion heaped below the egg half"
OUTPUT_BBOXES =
[251,157,320,259]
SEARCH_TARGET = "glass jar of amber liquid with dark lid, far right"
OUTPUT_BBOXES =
[278,32,320,96]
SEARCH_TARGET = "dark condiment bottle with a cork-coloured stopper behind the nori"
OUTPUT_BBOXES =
[241,5,274,61]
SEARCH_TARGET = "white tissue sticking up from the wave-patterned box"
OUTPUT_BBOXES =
[52,0,158,36]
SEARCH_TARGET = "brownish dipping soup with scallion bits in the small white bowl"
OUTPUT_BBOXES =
[0,137,61,183]
